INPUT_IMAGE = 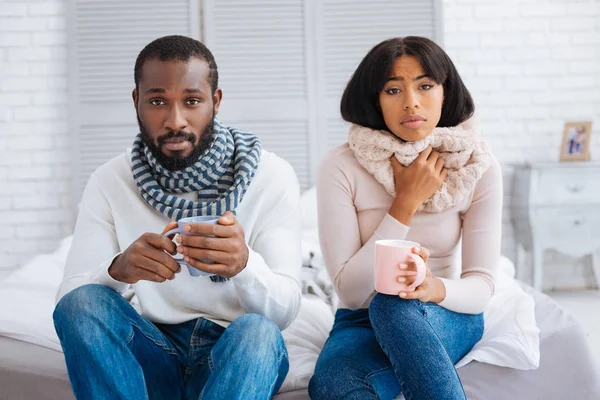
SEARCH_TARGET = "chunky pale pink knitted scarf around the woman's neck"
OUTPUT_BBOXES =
[348,118,491,213]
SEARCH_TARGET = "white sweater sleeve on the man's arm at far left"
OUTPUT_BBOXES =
[56,174,130,302]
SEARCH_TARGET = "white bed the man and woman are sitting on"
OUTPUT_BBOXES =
[0,188,600,400]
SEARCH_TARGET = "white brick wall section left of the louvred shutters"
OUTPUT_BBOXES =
[0,0,72,269]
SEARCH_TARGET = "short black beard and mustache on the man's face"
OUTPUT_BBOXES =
[137,115,215,171]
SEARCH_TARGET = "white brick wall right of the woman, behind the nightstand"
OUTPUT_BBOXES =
[444,0,600,289]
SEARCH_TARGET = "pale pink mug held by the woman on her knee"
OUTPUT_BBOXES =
[374,240,427,295]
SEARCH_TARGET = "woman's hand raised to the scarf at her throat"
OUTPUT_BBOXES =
[389,146,446,225]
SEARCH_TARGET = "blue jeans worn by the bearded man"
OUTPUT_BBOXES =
[54,285,289,400]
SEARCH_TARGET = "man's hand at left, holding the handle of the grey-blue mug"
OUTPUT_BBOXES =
[108,222,181,283]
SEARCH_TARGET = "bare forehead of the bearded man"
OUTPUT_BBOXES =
[140,58,210,87]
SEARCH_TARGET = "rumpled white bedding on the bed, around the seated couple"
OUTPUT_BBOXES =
[0,230,540,392]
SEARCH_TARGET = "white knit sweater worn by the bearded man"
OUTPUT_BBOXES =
[57,151,302,329]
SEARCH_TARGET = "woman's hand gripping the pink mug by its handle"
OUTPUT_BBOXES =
[398,247,446,303]
